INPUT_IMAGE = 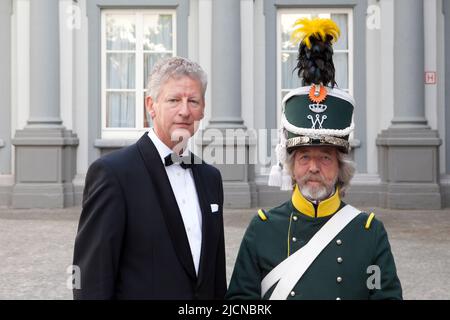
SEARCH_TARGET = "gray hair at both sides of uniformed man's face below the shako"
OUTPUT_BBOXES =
[284,149,356,197]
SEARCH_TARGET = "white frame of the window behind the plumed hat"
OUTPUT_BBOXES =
[276,7,355,127]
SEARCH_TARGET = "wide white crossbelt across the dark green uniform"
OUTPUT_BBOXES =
[261,205,361,300]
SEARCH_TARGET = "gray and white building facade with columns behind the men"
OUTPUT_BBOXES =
[0,0,450,209]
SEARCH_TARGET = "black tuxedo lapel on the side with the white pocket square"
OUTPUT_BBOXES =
[192,158,217,287]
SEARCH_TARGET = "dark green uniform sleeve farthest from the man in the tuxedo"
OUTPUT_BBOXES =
[369,221,403,300]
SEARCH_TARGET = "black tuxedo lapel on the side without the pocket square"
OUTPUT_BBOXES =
[137,133,196,281]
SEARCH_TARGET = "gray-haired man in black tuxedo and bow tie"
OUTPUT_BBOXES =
[73,57,226,299]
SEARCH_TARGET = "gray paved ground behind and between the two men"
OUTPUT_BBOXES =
[0,207,450,299]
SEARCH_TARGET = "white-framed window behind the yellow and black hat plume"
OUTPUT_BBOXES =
[277,8,353,123]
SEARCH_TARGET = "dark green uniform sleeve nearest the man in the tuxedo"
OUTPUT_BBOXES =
[225,217,262,300]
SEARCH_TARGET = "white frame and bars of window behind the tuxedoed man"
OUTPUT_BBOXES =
[100,8,178,139]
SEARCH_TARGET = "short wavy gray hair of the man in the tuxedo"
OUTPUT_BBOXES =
[147,57,208,101]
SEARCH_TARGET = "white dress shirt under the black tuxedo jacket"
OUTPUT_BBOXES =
[148,129,202,274]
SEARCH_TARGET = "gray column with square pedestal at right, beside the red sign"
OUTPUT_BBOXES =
[374,0,442,209]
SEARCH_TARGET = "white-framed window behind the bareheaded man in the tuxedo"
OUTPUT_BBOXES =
[101,10,176,139]
